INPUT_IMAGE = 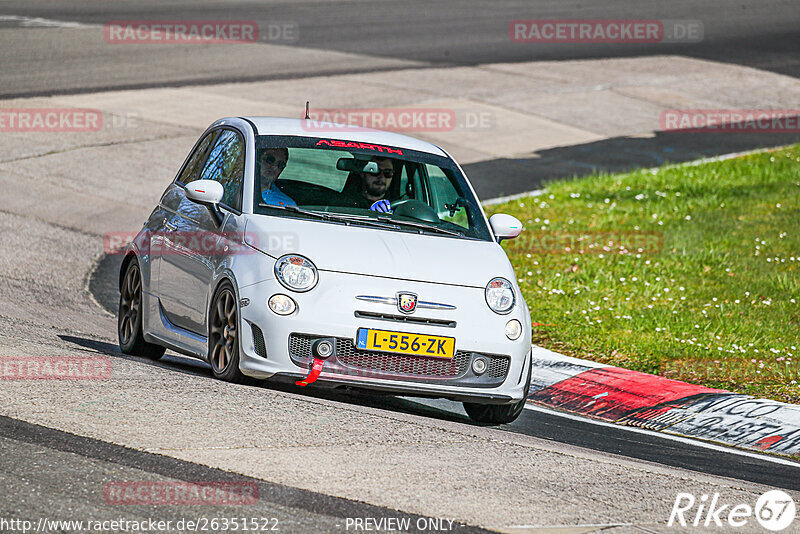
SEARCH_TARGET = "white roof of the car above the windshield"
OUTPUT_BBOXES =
[241,117,447,157]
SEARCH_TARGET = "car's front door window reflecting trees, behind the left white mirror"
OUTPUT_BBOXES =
[200,130,244,211]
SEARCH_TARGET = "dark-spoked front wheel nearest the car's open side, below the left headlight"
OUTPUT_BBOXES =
[208,282,246,383]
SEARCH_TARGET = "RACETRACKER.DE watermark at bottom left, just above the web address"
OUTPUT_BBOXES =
[103,481,258,506]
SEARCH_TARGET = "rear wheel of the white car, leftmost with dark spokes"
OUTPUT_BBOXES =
[117,257,166,360]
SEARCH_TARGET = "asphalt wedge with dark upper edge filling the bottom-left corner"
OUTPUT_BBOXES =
[0,416,487,533]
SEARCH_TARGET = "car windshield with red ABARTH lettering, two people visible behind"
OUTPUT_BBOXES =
[254,136,491,240]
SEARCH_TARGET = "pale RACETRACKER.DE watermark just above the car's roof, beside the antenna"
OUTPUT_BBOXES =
[301,108,494,132]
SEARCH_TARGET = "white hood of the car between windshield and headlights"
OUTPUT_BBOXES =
[245,215,514,288]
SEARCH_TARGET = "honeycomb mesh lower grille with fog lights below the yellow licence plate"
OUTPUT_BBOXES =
[289,334,511,382]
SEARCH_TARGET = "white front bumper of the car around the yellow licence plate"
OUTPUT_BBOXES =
[239,271,531,404]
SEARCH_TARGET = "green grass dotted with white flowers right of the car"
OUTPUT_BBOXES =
[490,145,800,402]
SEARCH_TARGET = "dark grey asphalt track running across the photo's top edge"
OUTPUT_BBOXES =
[0,0,800,96]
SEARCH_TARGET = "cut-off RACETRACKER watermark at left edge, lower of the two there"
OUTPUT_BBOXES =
[0,356,111,380]
